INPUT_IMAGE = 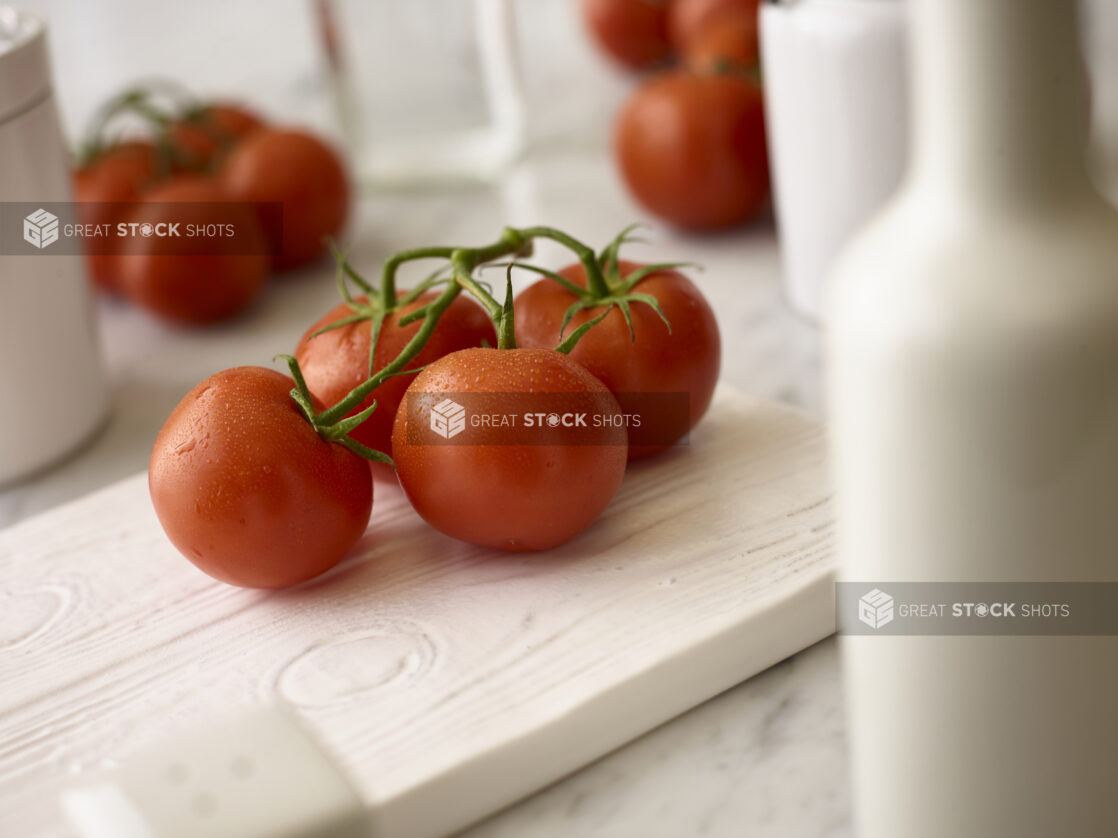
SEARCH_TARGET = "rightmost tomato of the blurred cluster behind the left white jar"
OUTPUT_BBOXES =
[221,128,349,269]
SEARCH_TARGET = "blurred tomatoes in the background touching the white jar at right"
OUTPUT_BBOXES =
[582,0,769,230]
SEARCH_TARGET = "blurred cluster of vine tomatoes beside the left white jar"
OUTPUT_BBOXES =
[73,91,350,324]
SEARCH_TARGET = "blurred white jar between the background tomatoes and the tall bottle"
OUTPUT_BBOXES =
[760,0,908,321]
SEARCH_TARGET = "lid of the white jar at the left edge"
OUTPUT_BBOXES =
[0,4,50,123]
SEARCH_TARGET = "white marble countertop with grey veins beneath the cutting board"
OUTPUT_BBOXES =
[0,0,850,838]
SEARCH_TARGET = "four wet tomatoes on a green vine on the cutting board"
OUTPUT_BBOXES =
[149,227,720,588]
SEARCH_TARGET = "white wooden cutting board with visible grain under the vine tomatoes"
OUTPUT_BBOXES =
[0,389,834,838]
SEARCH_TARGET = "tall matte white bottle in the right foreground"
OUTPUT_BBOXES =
[827,0,1118,838]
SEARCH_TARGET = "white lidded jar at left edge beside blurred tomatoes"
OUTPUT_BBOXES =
[0,6,108,484]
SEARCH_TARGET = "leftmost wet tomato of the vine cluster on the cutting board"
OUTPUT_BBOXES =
[148,366,372,588]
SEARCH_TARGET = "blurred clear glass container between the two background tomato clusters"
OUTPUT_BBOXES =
[315,0,524,188]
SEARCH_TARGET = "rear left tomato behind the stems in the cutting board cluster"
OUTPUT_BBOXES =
[295,292,496,454]
